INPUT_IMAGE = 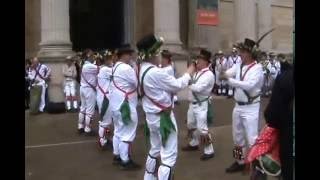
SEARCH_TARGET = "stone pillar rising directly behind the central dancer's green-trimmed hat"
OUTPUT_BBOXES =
[153,0,182,52]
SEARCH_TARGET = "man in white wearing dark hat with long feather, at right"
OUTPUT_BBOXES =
[219,38,263,173]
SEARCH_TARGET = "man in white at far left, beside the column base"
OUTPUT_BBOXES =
[28,57,51,113]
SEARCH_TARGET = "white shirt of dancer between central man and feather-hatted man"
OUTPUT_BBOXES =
[189,67,215,102]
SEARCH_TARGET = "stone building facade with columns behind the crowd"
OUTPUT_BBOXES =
[25,0,294,102]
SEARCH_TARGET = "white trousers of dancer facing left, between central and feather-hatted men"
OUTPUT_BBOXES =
[187,101,214,154]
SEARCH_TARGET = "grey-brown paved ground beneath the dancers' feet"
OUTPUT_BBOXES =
[25,98,268,180]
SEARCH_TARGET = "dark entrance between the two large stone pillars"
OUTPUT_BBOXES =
[69,0,124,51]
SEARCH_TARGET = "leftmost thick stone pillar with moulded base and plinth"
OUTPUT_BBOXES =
[38,0,73,102]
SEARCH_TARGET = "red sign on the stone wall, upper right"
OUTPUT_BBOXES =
[197,9,219,26]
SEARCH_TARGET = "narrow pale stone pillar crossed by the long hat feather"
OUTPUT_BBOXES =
[258,0,272,51]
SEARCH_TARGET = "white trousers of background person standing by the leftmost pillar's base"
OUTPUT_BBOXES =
[64,80,78,109]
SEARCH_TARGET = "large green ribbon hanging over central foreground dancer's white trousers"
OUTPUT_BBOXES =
[160,110,176,147]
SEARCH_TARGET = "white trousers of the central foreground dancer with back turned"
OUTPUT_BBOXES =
[144,112,178,180]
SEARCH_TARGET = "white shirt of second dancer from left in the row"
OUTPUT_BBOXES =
[97,65,112,96]
